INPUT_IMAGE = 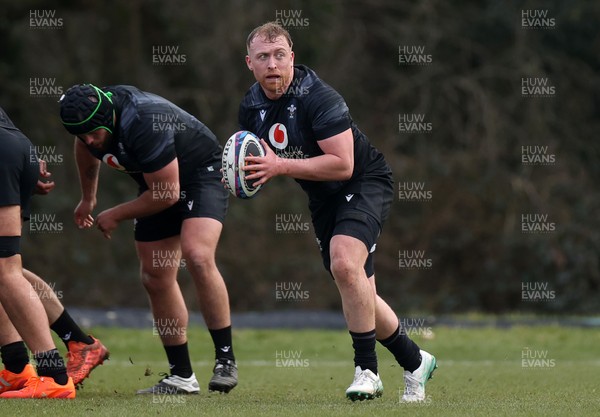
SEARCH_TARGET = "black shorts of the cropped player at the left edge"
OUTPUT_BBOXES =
[0,128,40,220]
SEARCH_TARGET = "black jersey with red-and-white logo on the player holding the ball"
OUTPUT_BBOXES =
[238,65,390,203]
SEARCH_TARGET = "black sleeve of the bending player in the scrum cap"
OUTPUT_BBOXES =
[127,115,177,173]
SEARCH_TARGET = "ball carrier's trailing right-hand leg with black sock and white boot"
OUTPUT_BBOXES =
[369,275,437,402]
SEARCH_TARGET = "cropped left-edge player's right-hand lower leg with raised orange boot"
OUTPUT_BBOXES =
[23,269,110,386]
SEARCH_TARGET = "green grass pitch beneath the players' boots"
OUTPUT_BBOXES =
[0,326,600,417]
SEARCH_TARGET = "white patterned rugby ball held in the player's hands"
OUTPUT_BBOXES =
[221,130,265,198]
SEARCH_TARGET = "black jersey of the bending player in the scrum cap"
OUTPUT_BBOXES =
[88,85,222,186]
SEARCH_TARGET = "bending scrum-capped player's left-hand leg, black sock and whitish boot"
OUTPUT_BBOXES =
[136,236,200,394]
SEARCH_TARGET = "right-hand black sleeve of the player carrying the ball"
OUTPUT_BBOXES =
[307,82,351,140]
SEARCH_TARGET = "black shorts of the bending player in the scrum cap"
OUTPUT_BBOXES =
[134,161,229,242]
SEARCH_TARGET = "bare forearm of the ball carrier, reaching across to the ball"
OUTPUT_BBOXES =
[277,154,354,181]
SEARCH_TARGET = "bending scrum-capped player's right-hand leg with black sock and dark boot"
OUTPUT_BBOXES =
[181,217,238,393]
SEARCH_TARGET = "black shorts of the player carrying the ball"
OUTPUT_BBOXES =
[311,175,394,277]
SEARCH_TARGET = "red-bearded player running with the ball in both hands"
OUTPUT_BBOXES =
[239,22,437,402]
